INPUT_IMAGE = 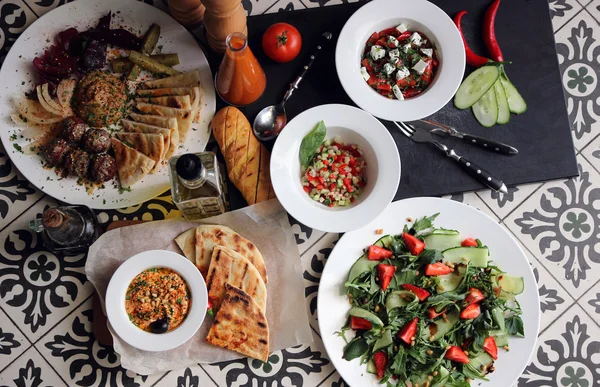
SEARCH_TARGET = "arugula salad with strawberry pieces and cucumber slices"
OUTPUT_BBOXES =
[339,214,524,387]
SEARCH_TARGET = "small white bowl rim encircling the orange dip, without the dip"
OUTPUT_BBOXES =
[106,250,208,351]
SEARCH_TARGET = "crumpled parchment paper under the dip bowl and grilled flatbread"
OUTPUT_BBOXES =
[85,199,313,375]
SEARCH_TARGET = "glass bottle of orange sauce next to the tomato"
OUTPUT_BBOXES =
[215,32,267,106]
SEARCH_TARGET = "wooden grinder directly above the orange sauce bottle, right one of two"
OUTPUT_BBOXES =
[202,0,248,52]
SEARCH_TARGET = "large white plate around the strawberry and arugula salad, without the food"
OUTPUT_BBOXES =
[317,198,540,387]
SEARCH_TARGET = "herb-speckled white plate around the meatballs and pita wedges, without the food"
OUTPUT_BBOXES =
[0,0,216,209]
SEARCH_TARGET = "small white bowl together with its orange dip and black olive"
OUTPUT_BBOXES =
[106,250,208,351]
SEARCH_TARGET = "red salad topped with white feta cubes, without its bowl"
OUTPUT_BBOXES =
[360,24,439,100]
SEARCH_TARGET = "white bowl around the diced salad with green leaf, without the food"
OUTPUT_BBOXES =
[271,104,400,232]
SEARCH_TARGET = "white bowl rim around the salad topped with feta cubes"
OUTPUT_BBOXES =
[335,0,465,121]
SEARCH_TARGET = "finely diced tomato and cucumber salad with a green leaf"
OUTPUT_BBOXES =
[300,121,367,207]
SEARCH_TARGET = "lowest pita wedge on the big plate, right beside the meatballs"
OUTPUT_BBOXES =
[111,137,155,188]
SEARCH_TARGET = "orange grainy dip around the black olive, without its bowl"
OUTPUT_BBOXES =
[125,267,191,333]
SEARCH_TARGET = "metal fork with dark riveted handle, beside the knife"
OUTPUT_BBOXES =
[394,122,508,193]
